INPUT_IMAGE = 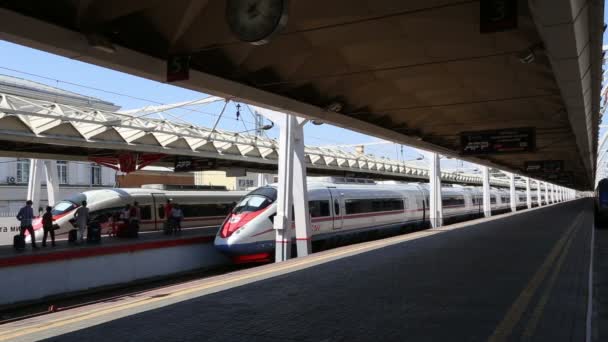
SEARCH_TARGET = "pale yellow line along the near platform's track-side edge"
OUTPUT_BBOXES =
[0,231,441,341]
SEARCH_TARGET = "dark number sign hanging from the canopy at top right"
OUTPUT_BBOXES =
[479,0,518,33]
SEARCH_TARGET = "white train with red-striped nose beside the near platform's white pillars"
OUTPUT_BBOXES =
[214,178,537,262]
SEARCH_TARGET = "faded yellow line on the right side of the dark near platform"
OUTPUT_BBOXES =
[488,213,582,342]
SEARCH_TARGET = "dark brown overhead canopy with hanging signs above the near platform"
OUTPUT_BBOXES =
[0,0,604,189]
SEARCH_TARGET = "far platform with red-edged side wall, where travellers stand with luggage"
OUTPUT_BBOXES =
[0,226,229,310]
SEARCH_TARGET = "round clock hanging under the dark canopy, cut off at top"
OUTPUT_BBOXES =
[226,0,288,45]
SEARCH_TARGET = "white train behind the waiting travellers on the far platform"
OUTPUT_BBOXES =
[26,188,247,241]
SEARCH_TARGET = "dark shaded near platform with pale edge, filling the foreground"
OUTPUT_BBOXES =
[0,199,593,342]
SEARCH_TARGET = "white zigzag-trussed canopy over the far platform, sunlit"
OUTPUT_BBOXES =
[0,87,525,189]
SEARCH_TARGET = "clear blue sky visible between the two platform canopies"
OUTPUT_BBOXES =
[0,13,608,171]
